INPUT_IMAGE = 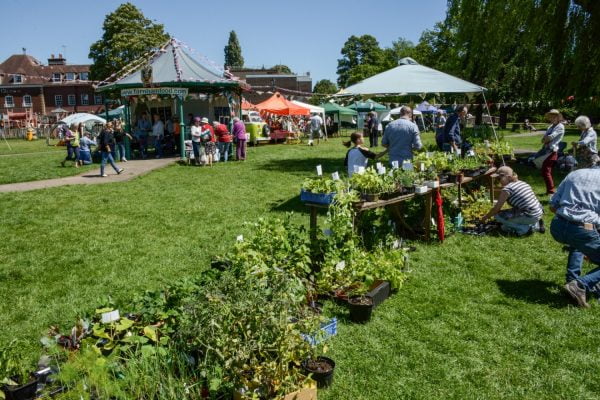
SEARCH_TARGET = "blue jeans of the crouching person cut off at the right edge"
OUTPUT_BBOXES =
[550,217,600,294]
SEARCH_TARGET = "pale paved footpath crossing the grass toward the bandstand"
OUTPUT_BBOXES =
[0,158,179,193]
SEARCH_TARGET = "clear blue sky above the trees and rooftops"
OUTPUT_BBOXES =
[0,0,446,83]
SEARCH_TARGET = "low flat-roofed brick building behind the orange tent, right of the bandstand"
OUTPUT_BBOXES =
[230,68,312,104]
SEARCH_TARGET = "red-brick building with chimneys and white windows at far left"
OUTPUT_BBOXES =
[0,54,103,120]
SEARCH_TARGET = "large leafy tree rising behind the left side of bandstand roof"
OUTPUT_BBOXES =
[88,3,169,80]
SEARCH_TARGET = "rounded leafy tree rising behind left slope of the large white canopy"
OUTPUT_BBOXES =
[337,35,386,87]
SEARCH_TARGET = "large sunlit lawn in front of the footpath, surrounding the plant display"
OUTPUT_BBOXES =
[0,139,600,400]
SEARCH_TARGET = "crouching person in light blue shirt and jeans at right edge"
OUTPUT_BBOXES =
[550,153,600,307]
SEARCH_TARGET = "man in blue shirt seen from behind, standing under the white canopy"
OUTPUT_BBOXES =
[381,106,423,166]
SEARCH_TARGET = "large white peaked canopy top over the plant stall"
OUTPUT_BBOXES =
[338,57,486,96]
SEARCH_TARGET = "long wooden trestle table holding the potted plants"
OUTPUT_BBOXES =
[305,168,498,242]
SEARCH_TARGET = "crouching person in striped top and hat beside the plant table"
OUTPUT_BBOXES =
[482,166,545,236]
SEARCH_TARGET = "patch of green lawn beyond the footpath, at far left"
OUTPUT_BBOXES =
[0,139,98,185]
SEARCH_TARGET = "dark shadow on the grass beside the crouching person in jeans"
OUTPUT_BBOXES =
[496,279,570,308]
